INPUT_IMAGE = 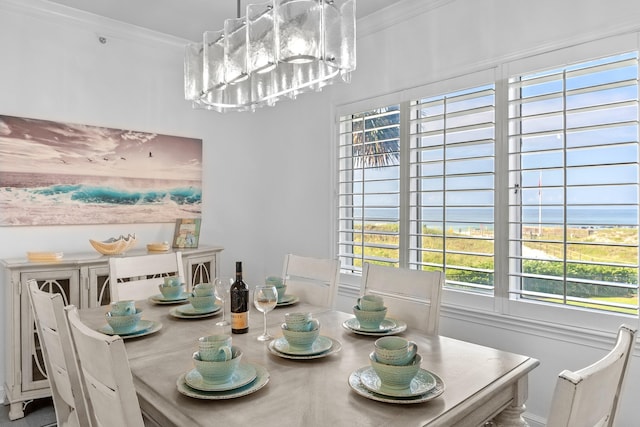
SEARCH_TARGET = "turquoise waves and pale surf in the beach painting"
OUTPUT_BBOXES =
[0,172,202,225]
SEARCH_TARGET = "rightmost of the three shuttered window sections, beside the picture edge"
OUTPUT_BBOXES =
[509,53,638,314]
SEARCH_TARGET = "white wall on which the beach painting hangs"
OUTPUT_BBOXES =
[0,0,338,410]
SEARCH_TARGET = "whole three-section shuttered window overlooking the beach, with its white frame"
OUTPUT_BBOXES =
[337,46,640,325]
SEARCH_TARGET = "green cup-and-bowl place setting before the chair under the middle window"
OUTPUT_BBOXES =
[342,294,407,336]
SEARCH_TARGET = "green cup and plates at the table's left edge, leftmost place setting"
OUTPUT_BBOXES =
[98,300,162,339]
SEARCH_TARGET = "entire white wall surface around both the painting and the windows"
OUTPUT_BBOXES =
[0,0,640,426]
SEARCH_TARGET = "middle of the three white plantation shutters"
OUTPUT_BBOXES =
[409,84,495,292]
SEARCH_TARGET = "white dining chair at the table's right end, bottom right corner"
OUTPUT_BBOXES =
[547,325,636,427]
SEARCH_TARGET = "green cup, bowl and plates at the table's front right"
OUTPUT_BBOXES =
[349,337,445,404]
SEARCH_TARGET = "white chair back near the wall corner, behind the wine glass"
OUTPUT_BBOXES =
[282,254,340,307]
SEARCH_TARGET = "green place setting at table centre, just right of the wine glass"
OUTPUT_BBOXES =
[269,312,342,360]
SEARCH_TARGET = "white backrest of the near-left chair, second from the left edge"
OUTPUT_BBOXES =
[65,306,144,427]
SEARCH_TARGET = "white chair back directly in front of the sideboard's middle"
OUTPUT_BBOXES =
[109,252,184,301]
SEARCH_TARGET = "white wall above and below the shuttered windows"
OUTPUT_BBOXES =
[332,0,640,427]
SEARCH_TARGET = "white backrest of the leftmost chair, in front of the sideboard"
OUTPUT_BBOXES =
[27,280,90,426]
